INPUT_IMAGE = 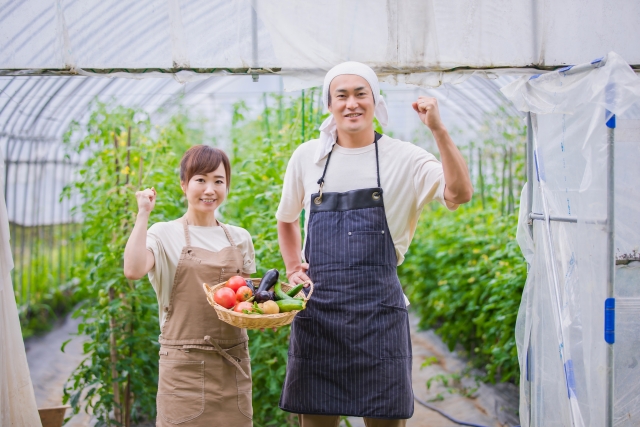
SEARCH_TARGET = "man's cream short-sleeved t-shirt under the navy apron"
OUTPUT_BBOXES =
[276,135,458,265]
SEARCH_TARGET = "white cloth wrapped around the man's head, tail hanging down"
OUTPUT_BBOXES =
[313,61,389,163]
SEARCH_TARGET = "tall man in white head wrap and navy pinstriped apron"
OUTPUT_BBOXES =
[276,62,473,427]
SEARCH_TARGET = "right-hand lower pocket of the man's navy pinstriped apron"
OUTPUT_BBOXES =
[377,303,411,359]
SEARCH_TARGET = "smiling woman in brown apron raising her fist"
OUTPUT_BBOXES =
[124,145,256,427]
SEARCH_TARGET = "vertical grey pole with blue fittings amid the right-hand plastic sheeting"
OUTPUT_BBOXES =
[605,116,616,427]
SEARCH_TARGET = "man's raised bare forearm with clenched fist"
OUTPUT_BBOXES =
[412,96,473,205]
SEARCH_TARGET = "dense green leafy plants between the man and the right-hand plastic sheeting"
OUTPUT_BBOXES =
[399,106,526,382]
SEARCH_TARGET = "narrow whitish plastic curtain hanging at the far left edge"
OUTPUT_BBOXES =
[0,153,42,427]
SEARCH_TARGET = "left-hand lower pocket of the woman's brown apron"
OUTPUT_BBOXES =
[157,360,204,424]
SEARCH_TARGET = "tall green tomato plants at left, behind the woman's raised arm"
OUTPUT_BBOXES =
[63,103,199,425]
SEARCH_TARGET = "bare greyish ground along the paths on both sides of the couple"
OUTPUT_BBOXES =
[25,316,519,427]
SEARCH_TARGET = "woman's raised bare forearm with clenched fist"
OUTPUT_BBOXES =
[124,188,156,280]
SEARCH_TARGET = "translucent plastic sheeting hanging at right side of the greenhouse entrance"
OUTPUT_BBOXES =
[503,53,640,427]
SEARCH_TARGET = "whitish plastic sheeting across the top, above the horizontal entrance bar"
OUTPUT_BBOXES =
[0,0,640,86]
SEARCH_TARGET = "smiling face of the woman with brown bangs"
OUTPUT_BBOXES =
[180,163,227,214]
